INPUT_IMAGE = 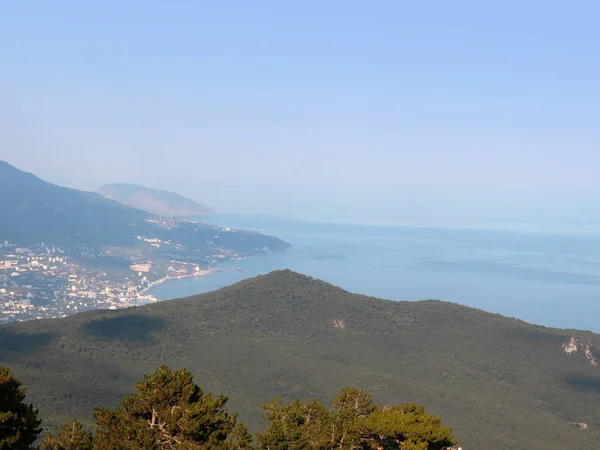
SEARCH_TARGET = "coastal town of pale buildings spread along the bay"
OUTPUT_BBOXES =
[0,236,241,324]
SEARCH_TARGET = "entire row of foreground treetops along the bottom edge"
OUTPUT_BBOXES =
[0,365,457,450]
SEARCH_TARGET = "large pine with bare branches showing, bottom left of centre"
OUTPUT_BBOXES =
[94,366,249,450]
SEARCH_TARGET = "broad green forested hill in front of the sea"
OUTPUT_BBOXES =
[0,271,600,450]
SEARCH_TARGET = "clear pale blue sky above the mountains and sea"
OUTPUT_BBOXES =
[0,0,600,223]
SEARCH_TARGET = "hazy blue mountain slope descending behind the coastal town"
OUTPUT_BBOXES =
[0,161,288,255]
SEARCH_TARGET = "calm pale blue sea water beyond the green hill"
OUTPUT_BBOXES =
[151,215,600,332]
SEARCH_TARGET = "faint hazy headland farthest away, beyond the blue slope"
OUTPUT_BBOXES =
[98,183,215,217]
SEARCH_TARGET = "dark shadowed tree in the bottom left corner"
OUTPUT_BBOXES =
[0,366,42,450]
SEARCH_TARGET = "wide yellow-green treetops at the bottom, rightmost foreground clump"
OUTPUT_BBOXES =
[258,388,457,450]
